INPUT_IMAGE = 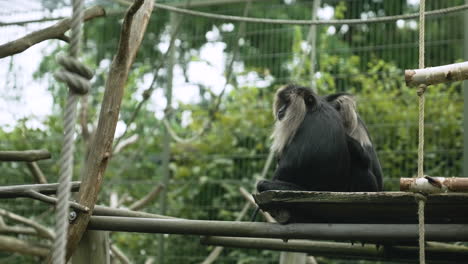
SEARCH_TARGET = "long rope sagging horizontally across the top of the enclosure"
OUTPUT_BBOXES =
[149,0,468,25]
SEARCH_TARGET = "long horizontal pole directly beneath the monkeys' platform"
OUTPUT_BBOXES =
[88,216,468,242]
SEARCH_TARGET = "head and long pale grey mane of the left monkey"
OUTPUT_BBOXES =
[271,85,319,154]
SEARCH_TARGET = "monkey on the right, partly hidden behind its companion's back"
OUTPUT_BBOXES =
[325,93,383,191]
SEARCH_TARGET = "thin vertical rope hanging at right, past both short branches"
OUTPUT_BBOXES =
[416,0,426,264]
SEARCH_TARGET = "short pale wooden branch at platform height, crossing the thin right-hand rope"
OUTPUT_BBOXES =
[400,176,468,193]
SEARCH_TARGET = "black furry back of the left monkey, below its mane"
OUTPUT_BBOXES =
[274,102,350,191]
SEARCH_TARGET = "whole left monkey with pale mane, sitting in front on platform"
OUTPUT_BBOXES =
[257,85,351,192]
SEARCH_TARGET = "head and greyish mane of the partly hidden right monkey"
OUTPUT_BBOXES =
[325,93,358,135]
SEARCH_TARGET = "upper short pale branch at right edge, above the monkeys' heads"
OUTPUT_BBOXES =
[405,62,468,86]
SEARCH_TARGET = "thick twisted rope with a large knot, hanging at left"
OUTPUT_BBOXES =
[52,0,93,264]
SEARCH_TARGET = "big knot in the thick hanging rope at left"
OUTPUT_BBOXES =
[54,54,93,95]
